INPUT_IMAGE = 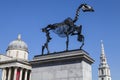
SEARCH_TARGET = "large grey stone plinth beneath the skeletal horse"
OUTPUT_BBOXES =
[30,50,94,80]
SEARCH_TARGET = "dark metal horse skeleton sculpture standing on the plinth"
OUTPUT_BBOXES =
[42,4,94,55]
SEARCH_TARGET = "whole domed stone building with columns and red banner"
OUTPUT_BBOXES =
[0,34,31,80]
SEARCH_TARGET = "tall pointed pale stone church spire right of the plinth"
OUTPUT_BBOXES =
[98,40,111,80]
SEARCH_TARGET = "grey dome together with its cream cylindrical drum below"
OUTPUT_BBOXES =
[6,34,28,60]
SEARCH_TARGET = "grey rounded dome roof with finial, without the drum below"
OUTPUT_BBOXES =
[7,34,28,52]
